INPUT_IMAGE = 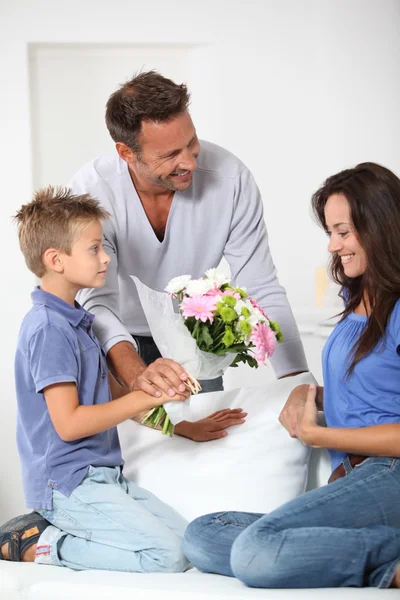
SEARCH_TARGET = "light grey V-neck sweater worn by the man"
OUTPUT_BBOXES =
[70,141,308,377]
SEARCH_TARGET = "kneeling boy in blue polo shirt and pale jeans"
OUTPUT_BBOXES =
[0,187,188,572]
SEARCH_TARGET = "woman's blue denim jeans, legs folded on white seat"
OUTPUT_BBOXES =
[183,457,400,588]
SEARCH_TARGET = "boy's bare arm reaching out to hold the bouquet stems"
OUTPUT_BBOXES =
[44,382,185,442]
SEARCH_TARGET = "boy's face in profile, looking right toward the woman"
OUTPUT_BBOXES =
[63,221,111,289]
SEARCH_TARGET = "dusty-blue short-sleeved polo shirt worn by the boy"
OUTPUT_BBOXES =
[15,288,122,510]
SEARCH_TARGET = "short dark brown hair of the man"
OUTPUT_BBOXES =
[106,71,190,153]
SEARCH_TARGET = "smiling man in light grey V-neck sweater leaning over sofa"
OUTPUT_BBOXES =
[70,71,308,441]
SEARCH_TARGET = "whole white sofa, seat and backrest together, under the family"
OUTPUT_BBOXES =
[0,374,399,600]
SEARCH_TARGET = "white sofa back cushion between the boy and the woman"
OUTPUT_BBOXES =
[119,373,315,520]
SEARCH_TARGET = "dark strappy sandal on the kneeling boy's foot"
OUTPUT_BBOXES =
[0,512,50,561]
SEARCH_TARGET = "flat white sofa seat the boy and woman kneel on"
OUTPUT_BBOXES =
[0,561,390,600]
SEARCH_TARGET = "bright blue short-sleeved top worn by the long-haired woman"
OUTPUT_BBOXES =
[322,301,400,470]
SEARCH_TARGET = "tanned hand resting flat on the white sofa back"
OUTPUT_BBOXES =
[175,408,247,442]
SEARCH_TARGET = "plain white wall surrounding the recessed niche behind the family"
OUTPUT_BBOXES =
[0,0,400,516]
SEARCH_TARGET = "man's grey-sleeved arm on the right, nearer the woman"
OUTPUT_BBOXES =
[224,169,308,377]
